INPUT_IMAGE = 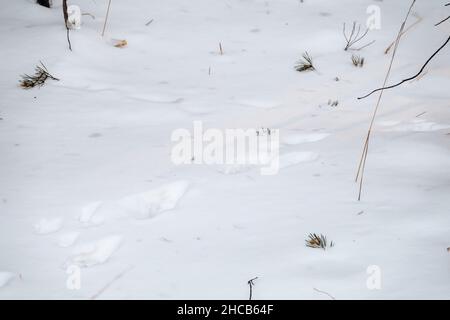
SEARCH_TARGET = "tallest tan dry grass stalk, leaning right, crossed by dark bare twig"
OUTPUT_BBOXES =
[355,0,416,201]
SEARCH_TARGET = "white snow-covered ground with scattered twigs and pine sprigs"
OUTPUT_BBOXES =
[0,0,450,299]
